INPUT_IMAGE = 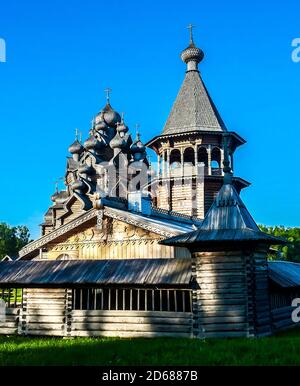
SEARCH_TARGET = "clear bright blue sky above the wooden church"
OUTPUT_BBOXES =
[0,0,300,237]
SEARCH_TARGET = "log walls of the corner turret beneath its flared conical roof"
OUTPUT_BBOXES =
[193,251,271,338]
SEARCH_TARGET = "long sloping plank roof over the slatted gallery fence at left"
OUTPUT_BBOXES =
[0,259,191,288]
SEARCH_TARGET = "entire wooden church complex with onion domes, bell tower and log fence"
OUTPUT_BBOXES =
[0,31,300,338]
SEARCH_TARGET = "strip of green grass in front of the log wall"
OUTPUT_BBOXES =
[0,329,300,366]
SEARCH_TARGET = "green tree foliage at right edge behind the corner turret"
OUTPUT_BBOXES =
[259,225,300,263]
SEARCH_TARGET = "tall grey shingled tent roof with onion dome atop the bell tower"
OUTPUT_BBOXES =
[162,27,227,134]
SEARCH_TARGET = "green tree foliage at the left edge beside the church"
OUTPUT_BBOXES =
[0,223,30,260]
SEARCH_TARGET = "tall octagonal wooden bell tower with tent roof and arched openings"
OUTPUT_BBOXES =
[146,25,249,218]
